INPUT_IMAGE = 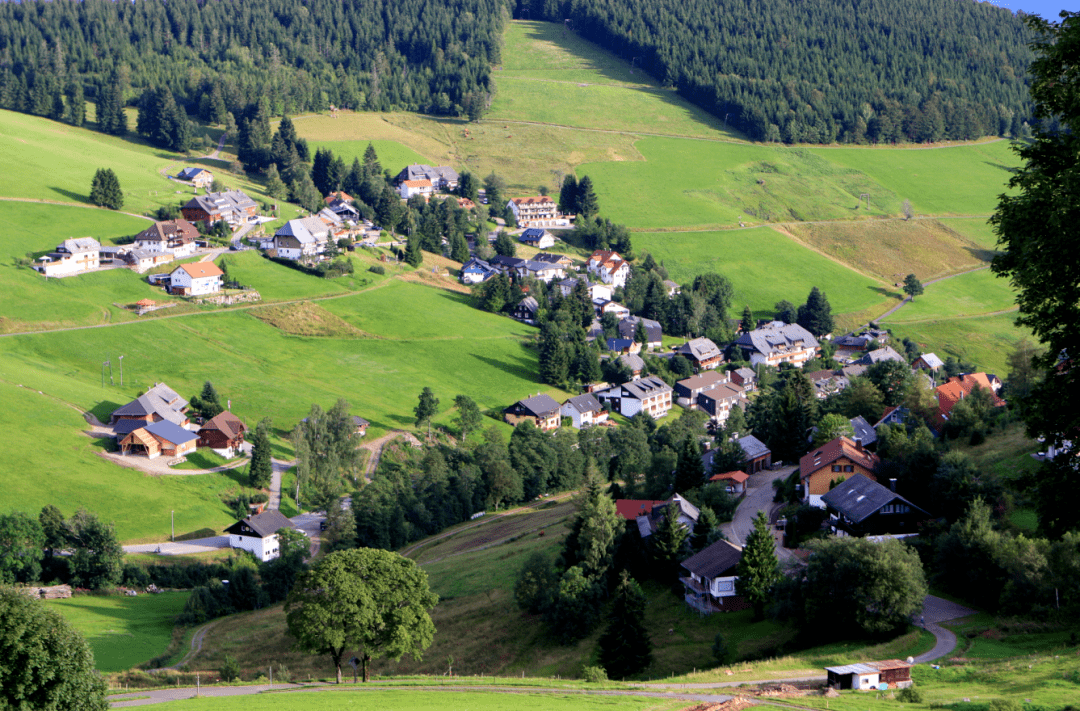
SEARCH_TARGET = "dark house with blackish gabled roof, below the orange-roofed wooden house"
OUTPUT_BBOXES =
[821,474,930,536]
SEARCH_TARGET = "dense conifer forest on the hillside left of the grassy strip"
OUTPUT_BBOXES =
[0,0,504,132]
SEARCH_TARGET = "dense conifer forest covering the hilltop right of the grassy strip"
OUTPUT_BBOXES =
[511,0,1031,143]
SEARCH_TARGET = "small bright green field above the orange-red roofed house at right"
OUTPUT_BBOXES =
[888,306,1034,374]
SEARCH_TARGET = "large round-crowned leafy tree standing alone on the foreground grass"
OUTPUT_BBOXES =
[285,548,438,684]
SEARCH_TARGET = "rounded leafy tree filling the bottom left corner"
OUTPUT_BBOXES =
[0,590,109,711]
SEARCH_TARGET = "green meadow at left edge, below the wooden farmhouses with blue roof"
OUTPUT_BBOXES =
[0,380,259,540]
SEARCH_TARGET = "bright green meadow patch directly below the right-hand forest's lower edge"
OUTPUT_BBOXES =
[812,140,1020,217]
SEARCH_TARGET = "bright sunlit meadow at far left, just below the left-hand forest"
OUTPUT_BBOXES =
[0,110,272,213]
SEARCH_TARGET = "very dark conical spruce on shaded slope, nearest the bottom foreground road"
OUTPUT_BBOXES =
[599,571,652,679]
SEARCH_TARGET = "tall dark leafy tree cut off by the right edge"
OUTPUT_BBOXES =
[990,12,1080,533]
